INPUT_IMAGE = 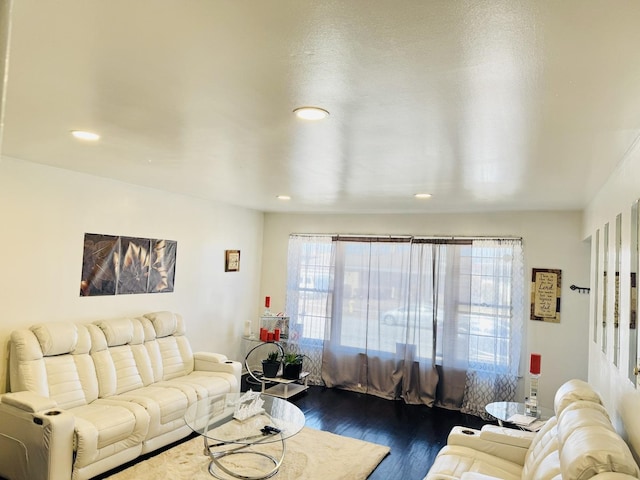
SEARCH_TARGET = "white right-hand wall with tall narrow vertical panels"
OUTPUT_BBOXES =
[583,137,640,458]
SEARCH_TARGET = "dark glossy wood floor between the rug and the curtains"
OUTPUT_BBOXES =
[292,387,487,480]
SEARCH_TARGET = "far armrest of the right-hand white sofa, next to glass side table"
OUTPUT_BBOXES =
[447,425,533,465]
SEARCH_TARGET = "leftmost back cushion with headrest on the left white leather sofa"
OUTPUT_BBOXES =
[10,322,98,408]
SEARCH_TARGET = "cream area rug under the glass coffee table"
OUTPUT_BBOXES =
[107,427,390,480]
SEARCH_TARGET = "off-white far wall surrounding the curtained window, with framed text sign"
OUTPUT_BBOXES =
[261,212,590,407]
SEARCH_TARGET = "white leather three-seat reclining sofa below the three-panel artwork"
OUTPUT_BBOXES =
[0,312,241,480]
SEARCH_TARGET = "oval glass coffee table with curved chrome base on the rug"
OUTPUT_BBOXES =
[184,392,305,480]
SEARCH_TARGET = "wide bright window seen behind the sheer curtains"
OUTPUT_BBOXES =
[287,235,521,371]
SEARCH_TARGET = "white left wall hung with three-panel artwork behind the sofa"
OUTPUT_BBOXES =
[0,157,263,392]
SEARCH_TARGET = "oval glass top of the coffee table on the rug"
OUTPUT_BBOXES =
[184,392,305,445]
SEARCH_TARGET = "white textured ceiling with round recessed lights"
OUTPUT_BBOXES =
[2,0,640,212]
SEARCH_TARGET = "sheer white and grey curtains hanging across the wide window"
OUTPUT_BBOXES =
[287,235,524,415]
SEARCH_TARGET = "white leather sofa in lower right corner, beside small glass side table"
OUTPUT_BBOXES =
[424,380,640,480]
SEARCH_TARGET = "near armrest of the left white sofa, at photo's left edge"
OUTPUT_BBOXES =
[0,392,75,480]
